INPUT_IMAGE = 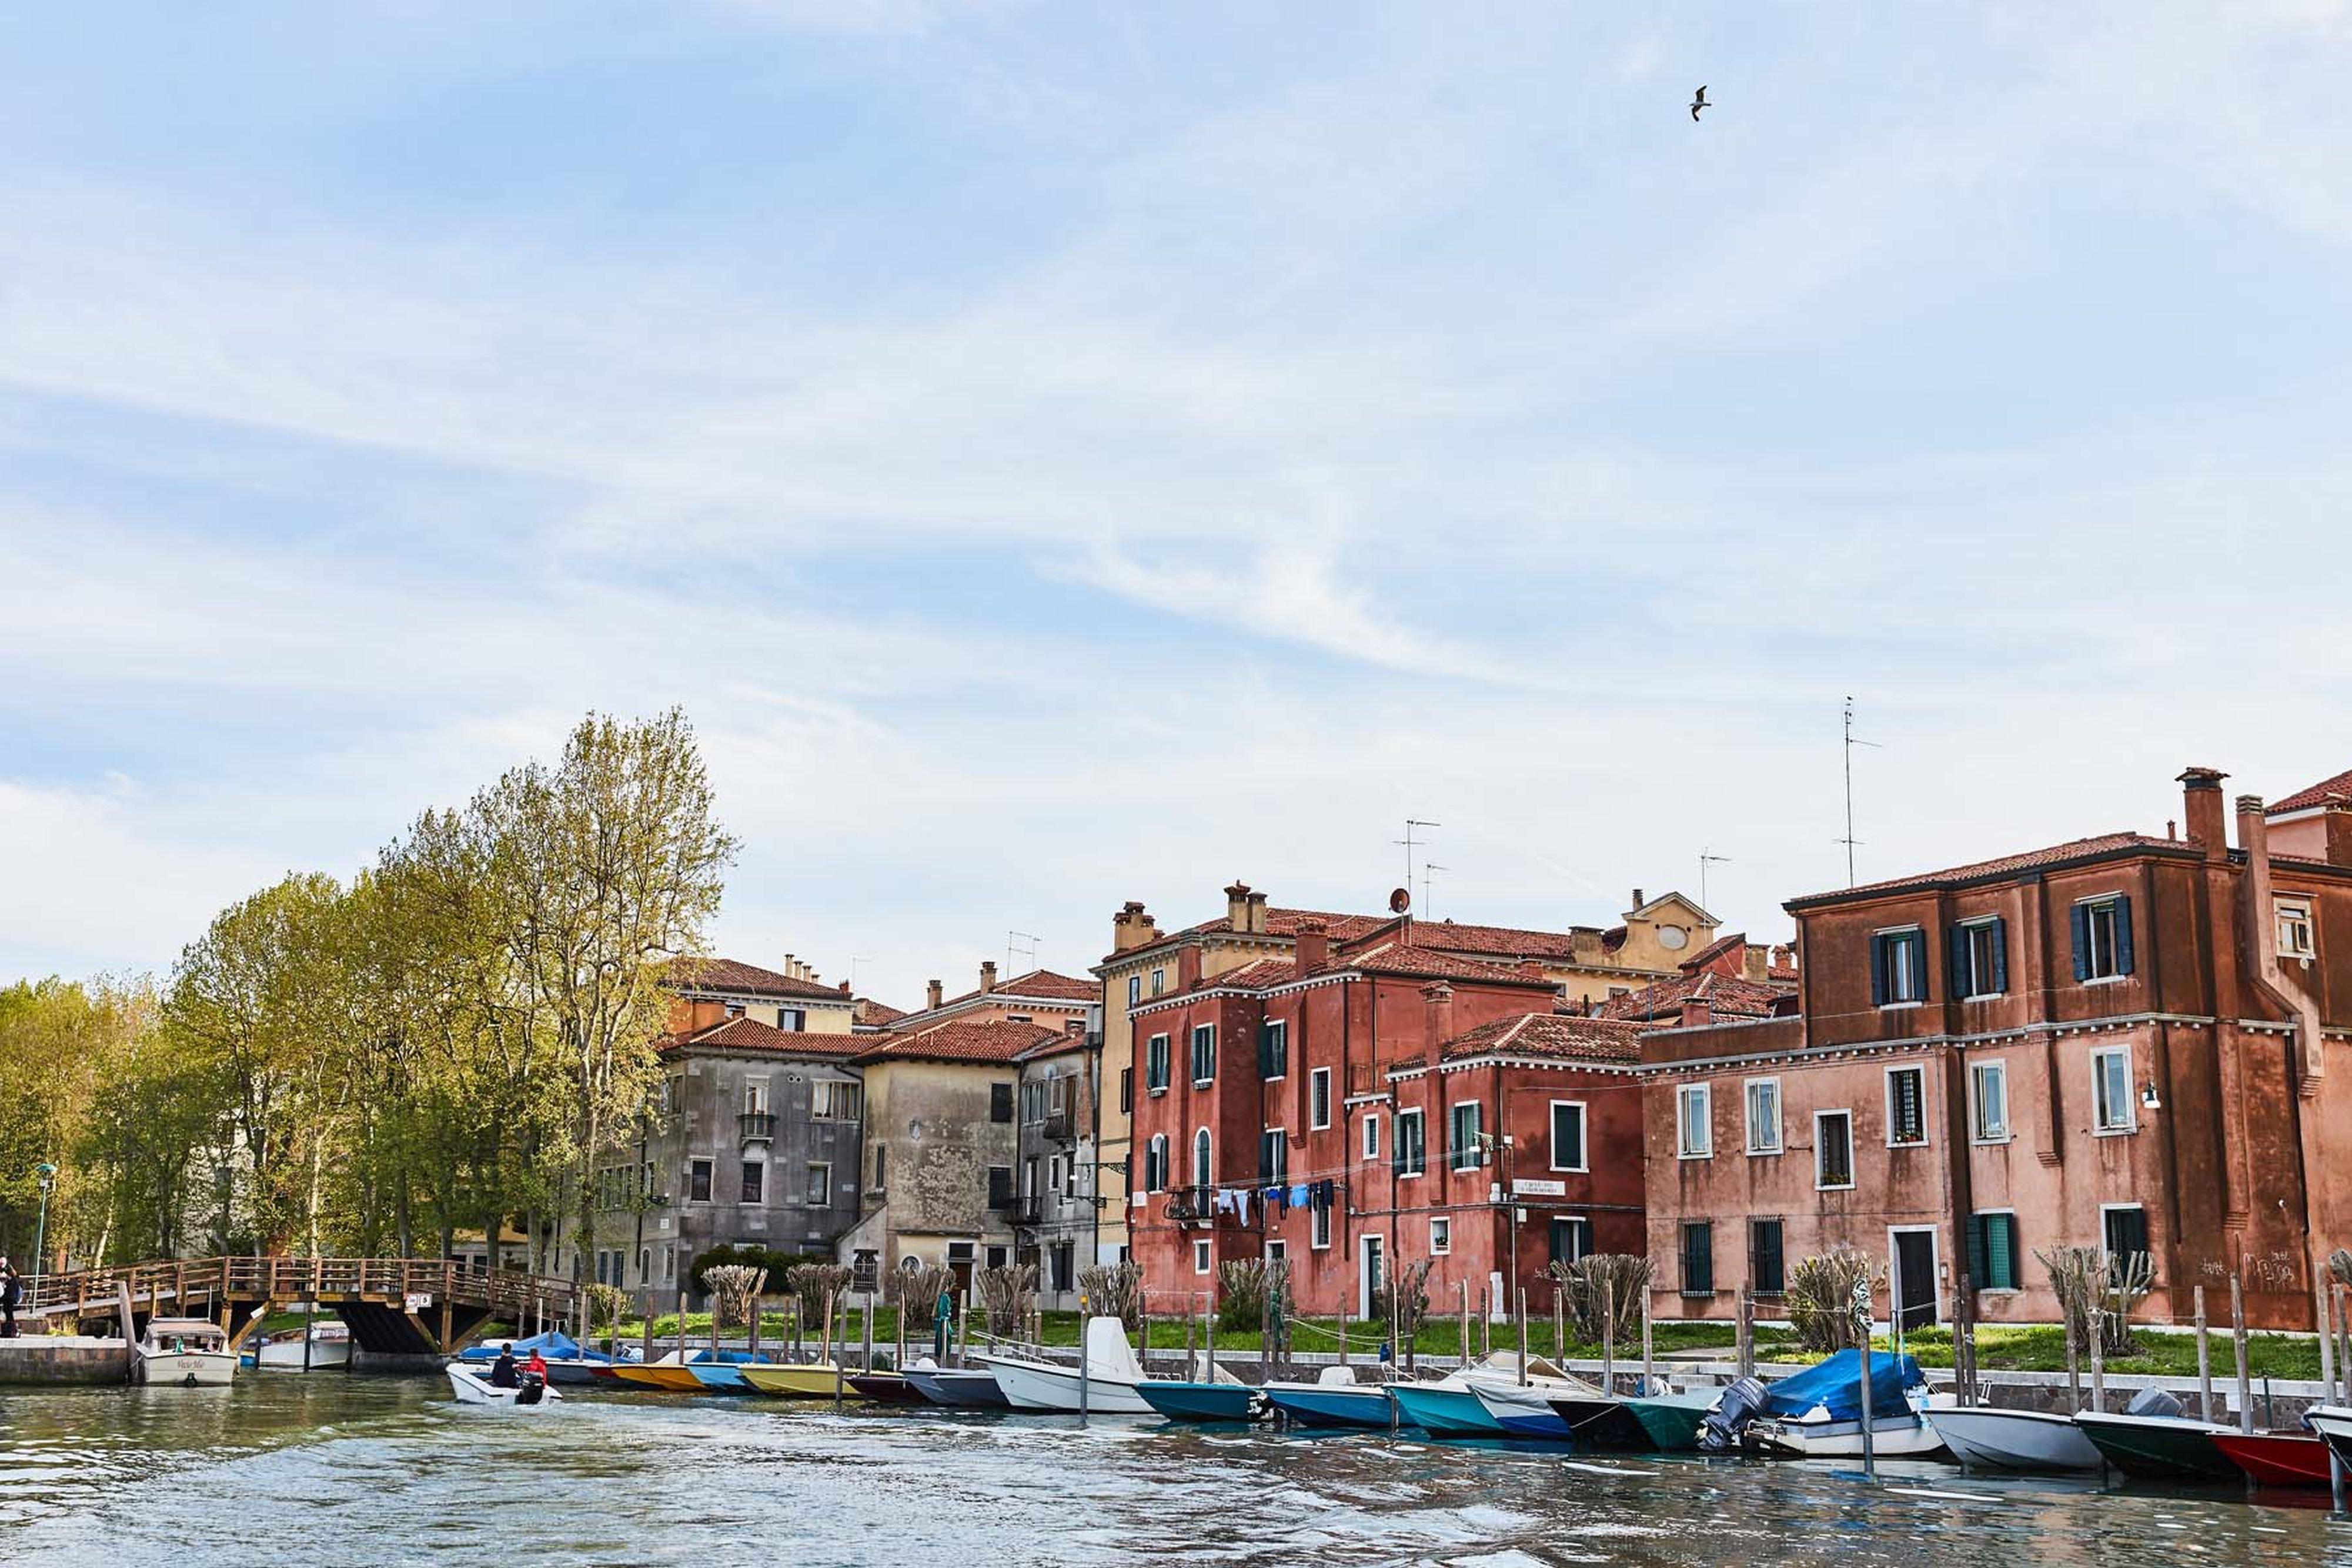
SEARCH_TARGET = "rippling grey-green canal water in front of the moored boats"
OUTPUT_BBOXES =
[0,1373,2352,1568]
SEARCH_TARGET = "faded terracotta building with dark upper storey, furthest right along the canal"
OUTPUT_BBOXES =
[1642,769,2352,1328]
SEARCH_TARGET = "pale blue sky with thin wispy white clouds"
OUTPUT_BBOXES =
[0,0,2352,1006]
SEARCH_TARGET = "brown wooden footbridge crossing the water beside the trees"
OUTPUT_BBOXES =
[21,1258,581,1356]
